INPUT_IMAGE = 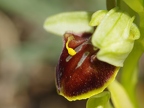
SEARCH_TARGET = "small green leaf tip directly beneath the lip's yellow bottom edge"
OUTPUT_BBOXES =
[86,91,112,108]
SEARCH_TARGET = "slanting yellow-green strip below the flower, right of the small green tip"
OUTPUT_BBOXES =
[108,80,134,108]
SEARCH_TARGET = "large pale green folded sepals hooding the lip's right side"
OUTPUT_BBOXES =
[91,9,140,67]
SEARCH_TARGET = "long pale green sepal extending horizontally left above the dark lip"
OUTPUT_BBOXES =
[44,11,93,36]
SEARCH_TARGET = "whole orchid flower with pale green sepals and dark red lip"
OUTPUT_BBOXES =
[44,3,140,108]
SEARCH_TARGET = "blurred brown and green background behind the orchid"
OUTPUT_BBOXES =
[0,0,144,108]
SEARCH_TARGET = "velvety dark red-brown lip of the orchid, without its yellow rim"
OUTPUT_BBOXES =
[56,33,116,97]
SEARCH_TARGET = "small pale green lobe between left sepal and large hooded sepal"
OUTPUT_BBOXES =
[90,10,107,26]
